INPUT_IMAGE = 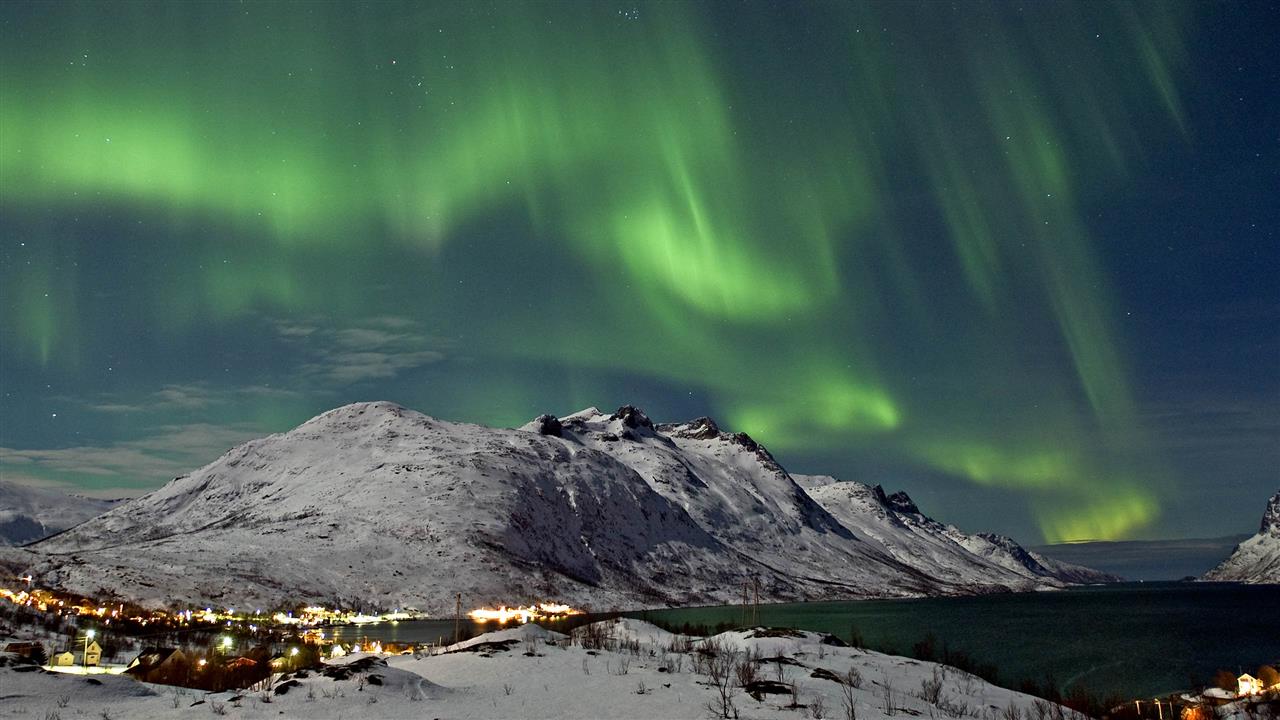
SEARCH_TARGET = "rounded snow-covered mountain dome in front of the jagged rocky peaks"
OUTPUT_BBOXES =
[24,402,762,611]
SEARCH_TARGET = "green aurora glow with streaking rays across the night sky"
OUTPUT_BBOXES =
[0,3,1269,542]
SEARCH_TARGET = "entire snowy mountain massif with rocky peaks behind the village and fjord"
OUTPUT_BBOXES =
[0,402,1110,614]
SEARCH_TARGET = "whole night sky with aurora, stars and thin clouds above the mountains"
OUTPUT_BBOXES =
[0,1,1280,542]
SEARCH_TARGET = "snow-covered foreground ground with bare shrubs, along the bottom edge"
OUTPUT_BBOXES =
[0,620,1070,720]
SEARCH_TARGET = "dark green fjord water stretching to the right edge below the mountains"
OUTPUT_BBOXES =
[628,583,1280,698]
